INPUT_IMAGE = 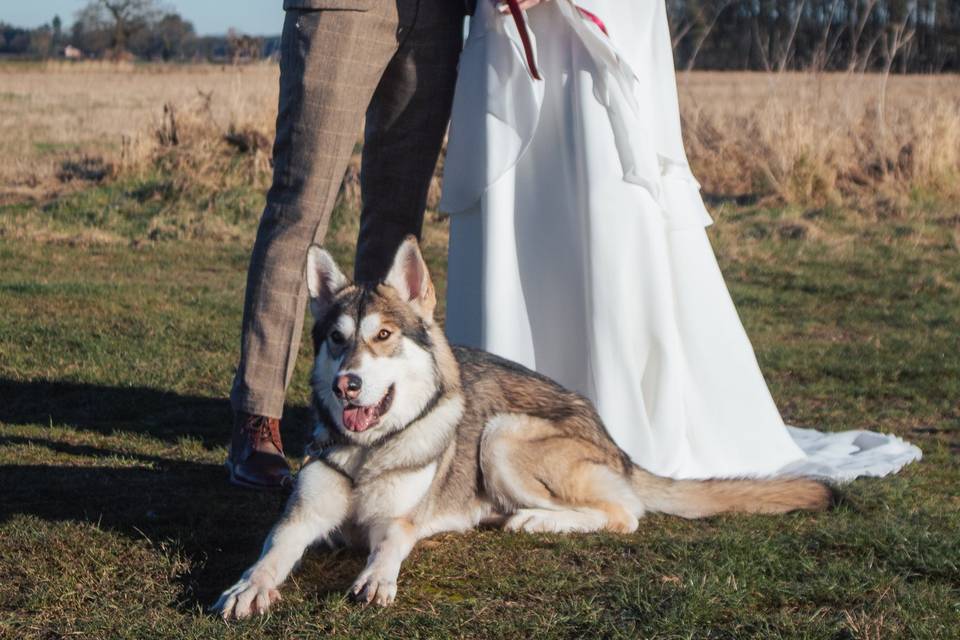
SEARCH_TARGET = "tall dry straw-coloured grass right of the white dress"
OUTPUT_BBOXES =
[680,73,960,213]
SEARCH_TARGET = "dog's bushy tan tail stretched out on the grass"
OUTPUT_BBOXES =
[630,467,833,518]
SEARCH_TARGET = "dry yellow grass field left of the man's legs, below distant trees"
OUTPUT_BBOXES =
[0,63,279,202]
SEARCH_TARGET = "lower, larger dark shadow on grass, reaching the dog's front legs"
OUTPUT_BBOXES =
[0,436,363,612]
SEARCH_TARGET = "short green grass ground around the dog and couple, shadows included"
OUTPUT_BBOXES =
[0,62,960,640]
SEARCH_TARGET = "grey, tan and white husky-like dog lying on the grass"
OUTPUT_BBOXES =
[213,237,831,619]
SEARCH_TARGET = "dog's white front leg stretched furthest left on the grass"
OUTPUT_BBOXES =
[211,461,351,620]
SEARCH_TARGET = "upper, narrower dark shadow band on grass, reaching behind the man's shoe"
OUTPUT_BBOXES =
[0,378,309,457]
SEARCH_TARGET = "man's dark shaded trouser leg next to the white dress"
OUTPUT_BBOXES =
[355,0,464,282]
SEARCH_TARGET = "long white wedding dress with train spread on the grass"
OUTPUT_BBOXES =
[440,0,920,481]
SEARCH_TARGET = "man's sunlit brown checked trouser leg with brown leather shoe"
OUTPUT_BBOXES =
[228,2,398,486]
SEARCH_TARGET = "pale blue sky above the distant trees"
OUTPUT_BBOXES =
[0,0,283,36]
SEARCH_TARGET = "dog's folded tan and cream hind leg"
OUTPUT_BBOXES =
[480,414,642,533]
